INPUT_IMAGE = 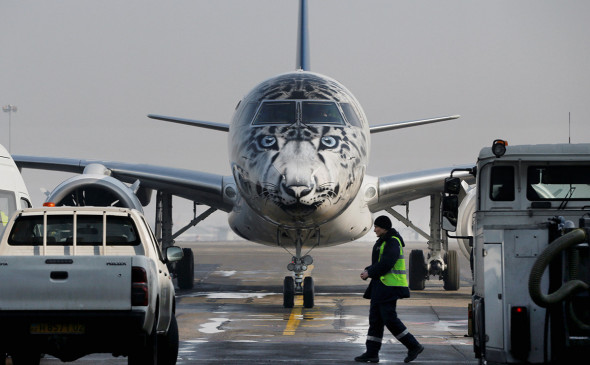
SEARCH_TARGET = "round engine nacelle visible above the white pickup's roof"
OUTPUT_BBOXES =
[46,164,143,213]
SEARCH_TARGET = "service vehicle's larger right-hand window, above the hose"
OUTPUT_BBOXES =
[527,165,590,201]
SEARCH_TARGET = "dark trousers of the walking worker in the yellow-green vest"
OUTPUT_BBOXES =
[366,300,419,354]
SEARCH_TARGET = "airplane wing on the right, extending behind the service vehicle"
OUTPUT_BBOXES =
[369,165,475,212]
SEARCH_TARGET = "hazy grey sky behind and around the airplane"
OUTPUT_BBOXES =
[0,0,590,240]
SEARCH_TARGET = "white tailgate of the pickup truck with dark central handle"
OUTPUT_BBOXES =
[0,256,132,310]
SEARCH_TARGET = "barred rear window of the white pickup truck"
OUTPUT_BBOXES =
[8,215,141,246]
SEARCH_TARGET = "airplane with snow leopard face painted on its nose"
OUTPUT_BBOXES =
[14,0,474,308]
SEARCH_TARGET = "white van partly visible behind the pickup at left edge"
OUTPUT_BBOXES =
[0,145,32,237]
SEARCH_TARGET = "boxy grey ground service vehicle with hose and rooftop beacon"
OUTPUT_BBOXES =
[442,140,590,364]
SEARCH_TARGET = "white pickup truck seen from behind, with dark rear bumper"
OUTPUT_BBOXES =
[0,207,182,365]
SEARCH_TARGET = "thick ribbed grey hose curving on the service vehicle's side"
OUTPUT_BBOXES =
[529,229,589,308]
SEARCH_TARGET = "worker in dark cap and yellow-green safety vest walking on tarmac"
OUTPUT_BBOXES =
[354,215,424,363]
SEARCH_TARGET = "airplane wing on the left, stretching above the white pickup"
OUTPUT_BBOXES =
[13,155,234,212]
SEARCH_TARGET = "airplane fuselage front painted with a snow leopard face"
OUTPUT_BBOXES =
[228,71,371,245]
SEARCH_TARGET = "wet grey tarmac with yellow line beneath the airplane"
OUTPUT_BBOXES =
[30,242,477,364]
